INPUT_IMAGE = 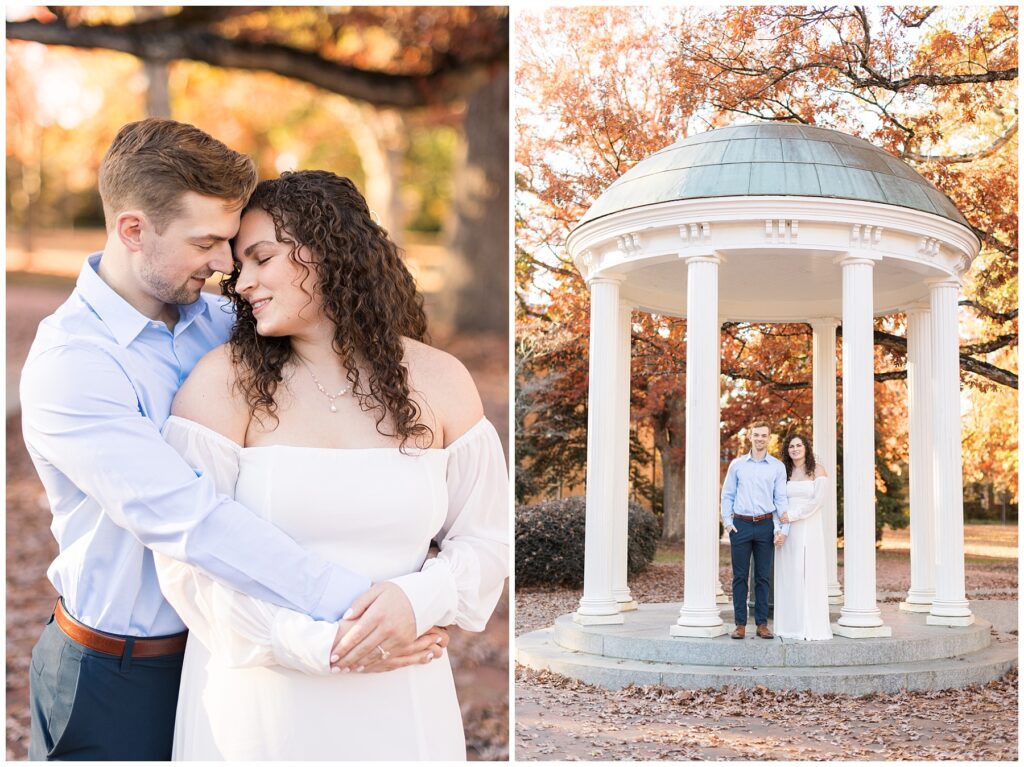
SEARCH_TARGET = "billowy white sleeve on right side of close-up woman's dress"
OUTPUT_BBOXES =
[391,419,509,635]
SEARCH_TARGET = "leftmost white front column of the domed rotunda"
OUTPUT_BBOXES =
[572,276,623,626]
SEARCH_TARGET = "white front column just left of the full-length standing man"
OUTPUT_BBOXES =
[670,255,728,637]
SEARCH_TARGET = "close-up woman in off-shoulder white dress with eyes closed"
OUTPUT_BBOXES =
[149,171,508,760]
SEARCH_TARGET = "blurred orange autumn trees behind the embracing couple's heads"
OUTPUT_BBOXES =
[5,6,508,331]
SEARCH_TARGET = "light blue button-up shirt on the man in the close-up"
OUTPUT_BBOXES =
[22,253,370,637]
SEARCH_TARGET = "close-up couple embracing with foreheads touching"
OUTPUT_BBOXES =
[22,120,508,761]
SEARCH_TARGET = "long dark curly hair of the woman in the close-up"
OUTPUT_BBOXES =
[222,170,433,449]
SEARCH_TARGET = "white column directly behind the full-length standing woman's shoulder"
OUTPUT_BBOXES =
[811,317,843,604]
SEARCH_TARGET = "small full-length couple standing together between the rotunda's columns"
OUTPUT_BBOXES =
[722,422,833,640]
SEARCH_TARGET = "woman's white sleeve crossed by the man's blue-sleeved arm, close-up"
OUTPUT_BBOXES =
[154,416,338,675]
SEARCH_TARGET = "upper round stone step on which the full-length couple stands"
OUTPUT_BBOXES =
[552,603,991,668]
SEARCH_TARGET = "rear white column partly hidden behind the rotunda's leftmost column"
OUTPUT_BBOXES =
[611,301,637,612]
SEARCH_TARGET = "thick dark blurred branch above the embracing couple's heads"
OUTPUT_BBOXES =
[7,17,508,109]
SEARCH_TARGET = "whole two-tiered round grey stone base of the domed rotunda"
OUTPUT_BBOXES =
[516,604,1017,695]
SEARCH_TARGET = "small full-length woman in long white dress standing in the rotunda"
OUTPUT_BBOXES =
[775,434,833,639]
